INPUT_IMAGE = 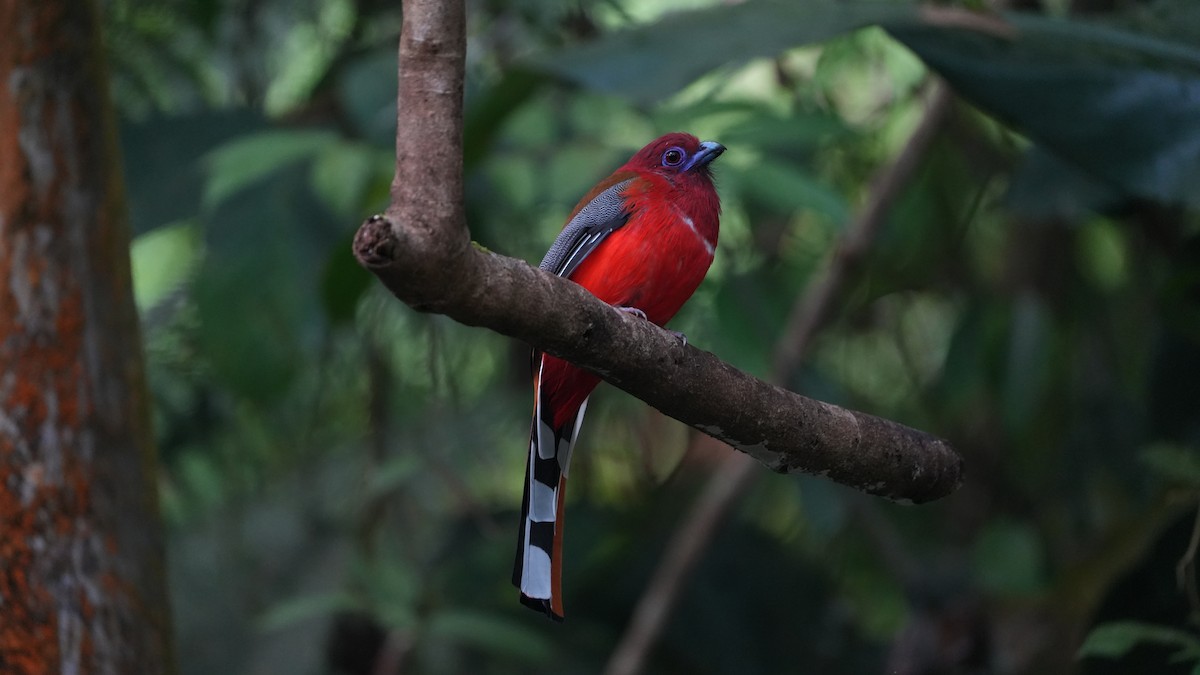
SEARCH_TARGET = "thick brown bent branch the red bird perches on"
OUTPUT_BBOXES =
[354,0,961,503]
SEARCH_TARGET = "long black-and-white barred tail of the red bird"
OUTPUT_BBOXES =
[512,358,588,621]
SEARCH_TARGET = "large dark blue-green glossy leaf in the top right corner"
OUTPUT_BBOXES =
[887,14,1200,204]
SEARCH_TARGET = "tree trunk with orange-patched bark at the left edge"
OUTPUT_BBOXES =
[0,0,172,675]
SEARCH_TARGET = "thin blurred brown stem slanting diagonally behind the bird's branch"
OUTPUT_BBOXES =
[605,80,952,675]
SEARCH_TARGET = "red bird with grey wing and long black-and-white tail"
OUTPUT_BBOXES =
[512,132,725,621]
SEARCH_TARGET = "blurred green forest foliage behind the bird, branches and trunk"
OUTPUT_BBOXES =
[101,0,1200,675]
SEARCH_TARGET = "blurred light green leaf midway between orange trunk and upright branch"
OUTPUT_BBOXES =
[204,130,337,208]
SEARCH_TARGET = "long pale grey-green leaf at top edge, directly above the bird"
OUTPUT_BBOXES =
[535,0,916,104]
